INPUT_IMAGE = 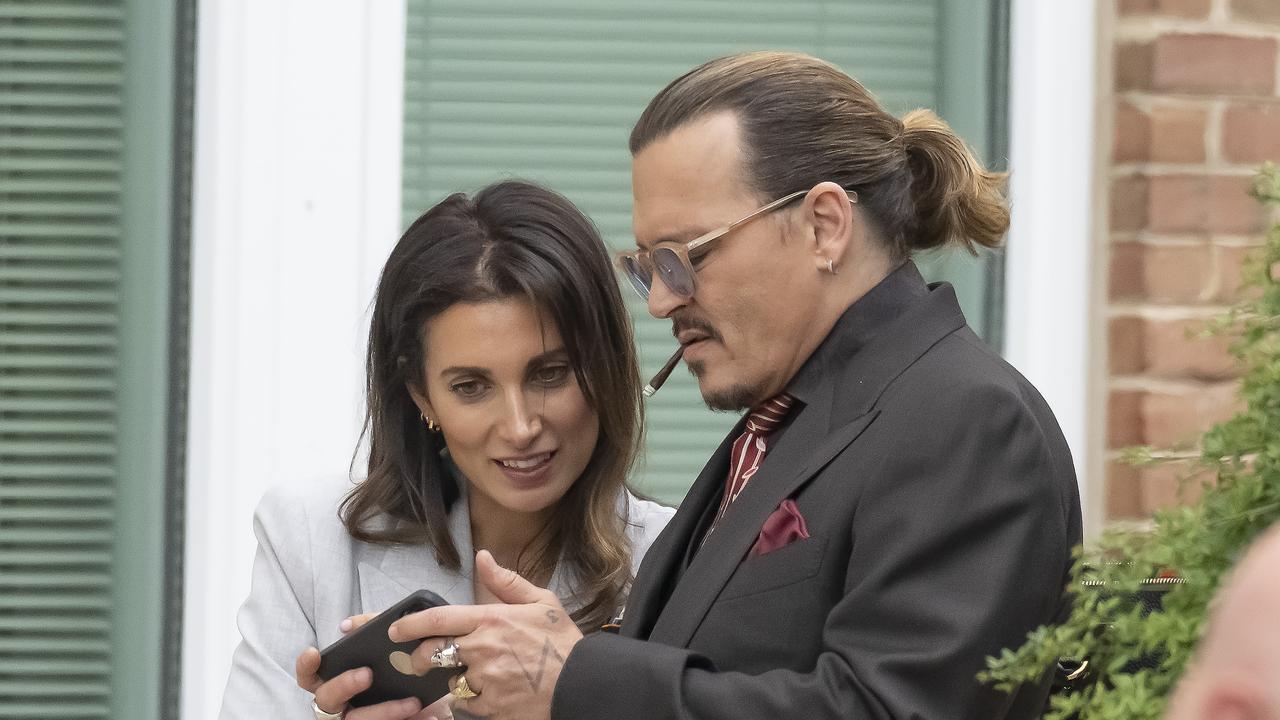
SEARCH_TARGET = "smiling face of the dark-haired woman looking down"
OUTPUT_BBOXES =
[411,299,600,515]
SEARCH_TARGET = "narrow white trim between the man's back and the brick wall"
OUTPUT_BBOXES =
[1005,0,1106,534]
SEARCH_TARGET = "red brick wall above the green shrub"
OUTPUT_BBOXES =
[1103,0,1280,519]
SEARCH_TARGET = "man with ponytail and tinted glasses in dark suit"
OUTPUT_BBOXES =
[393,53,1080,720]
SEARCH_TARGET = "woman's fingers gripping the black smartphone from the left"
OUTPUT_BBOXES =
[294,612,453,720]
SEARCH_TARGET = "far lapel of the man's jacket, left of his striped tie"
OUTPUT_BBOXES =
[621,420,745,638]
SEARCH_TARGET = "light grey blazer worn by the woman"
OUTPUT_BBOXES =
[219,478,675,720]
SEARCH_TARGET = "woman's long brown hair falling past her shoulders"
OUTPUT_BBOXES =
[340,181,644,629]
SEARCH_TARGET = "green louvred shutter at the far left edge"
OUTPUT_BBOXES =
[0,0,168,720]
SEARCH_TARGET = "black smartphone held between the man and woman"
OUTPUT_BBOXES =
[317,591,466,707]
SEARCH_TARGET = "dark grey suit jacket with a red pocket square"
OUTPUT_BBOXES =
[552,263,1082,720]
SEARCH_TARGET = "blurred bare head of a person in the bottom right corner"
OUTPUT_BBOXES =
[1169,527,1280,720]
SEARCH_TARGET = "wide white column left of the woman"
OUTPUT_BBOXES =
[182,0,404,720]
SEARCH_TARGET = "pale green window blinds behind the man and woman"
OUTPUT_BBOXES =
[403,0,998,502]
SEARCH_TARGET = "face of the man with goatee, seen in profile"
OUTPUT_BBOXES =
[631,113,819,410]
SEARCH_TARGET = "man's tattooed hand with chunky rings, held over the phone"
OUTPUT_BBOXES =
[388,550,582,720]
